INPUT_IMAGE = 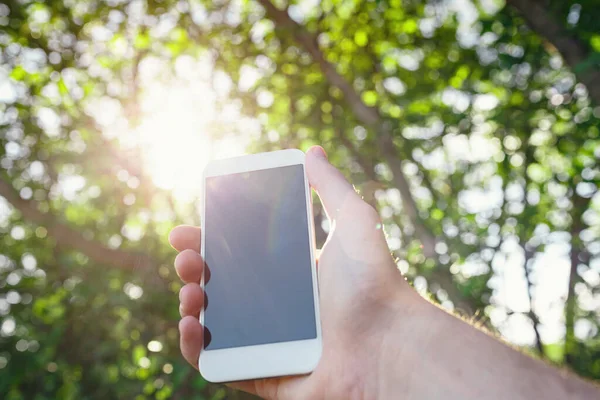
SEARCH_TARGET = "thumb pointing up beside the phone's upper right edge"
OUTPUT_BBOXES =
[306,146,359,219]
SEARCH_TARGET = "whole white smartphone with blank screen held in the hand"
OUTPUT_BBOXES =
[198,150,322,382]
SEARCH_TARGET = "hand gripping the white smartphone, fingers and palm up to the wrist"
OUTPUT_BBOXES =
[169,147,427,399]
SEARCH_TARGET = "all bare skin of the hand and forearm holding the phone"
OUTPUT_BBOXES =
[169,146,600,399]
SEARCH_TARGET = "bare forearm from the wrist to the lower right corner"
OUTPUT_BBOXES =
[380,304,600,400]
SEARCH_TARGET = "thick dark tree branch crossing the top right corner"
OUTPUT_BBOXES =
[507,0,600,104]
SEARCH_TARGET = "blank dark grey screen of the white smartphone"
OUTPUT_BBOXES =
[203,165,317,350]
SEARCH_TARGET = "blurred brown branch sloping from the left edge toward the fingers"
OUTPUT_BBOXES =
[0,179,156,270]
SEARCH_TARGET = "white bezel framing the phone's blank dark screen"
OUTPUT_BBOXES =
[198,149,322,382]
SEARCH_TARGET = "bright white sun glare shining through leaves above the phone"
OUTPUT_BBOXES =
[131,55,256,200]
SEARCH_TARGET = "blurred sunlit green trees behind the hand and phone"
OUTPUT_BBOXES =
[0,0,600,400]
